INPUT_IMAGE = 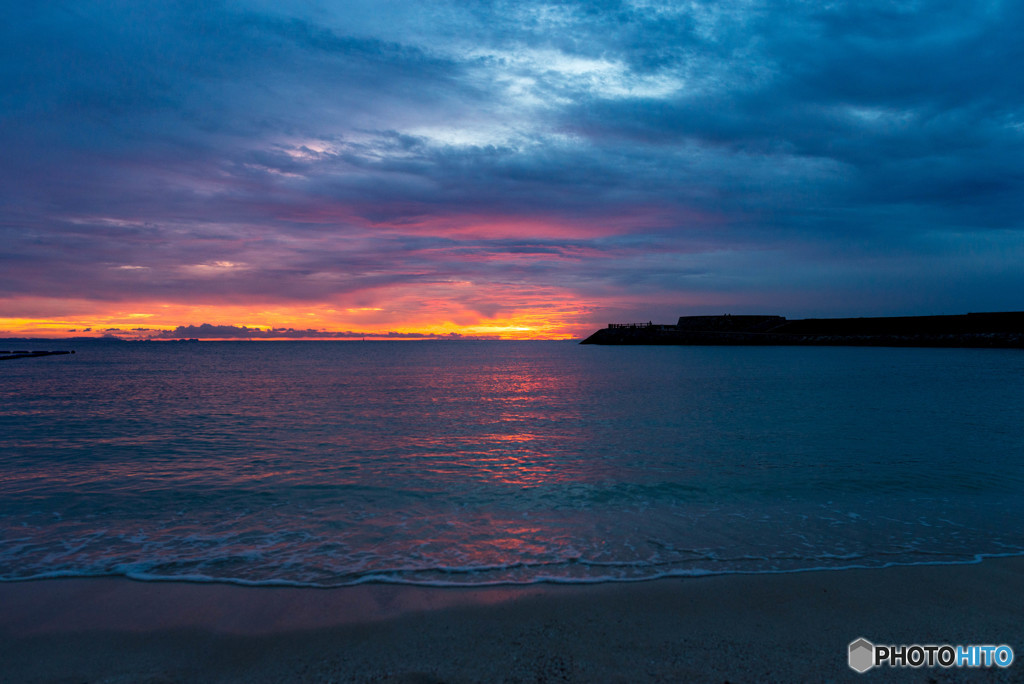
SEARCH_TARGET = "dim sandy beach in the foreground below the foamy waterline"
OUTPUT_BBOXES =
[0,557,1024,684]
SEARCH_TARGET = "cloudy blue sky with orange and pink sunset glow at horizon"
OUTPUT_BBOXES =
[0,0,1024,339]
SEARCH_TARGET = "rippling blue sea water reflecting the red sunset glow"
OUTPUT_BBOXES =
[0,341,1024,586]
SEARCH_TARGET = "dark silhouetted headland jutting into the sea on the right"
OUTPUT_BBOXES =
[581,311,1024,348]
